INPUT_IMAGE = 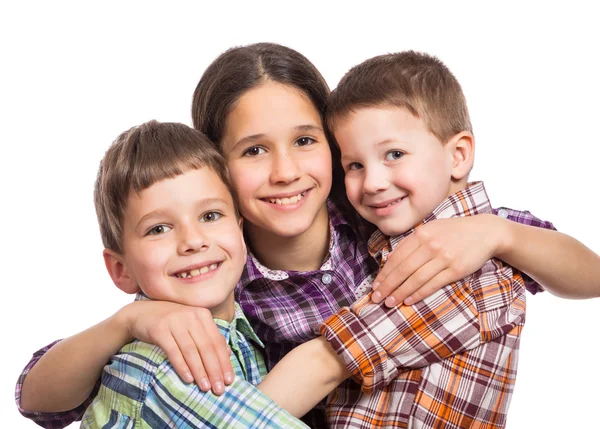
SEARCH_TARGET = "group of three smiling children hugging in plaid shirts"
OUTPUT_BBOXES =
[17,44,598,428]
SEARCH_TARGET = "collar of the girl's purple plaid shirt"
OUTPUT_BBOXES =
[241,199,350,287]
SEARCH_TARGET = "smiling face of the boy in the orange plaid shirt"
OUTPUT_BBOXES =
[334,106,454,235]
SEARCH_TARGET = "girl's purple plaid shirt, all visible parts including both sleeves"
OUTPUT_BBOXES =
[15,198,554,429]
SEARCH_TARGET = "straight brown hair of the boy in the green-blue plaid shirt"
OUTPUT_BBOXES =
[94,121,238,253]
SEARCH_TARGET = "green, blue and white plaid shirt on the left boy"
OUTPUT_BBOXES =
[81,306,306,429]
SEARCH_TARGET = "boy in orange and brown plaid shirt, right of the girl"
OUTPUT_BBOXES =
[267,51,540,428]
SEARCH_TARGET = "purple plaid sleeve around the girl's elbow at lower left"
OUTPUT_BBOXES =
[15,340,100,429]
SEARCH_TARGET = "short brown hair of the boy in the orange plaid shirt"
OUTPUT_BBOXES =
[327,51,473,143]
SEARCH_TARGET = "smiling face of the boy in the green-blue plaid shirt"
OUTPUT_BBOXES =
[116,167,246,320]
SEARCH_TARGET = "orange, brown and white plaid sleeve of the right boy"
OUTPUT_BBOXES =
[321,259,525,393]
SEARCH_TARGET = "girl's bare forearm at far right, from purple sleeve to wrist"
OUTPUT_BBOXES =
[495,219,600,299]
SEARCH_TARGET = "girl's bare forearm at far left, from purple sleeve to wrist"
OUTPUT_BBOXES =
[21,313,133,412]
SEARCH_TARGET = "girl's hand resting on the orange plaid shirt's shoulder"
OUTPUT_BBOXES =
[372,215,502,307]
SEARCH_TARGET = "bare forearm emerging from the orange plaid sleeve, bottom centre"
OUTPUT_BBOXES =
[258,337,350,417]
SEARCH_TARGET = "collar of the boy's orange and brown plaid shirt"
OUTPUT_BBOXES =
[369,182,492,261]
